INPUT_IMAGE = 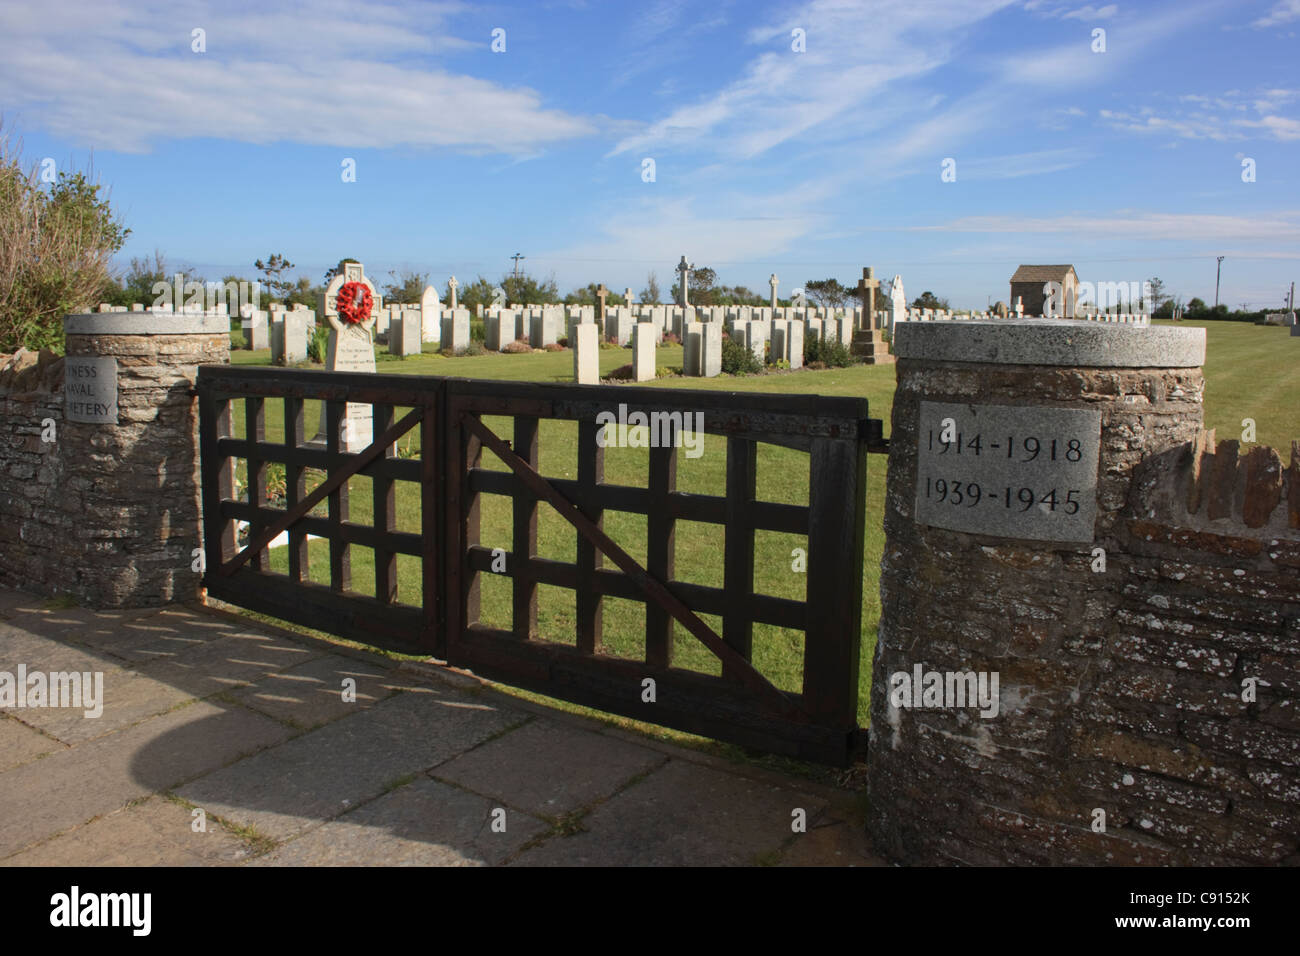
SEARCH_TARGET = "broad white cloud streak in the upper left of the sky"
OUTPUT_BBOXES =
[0,0,599,153]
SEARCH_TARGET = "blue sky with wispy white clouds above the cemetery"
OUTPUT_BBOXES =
[0,0,1300,308]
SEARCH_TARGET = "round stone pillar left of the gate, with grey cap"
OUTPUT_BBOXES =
[57,312,230,607]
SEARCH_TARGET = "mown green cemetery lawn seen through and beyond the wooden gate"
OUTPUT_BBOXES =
[218,323,1300,764]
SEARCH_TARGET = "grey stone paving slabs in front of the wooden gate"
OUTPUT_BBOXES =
[0,588,883,866]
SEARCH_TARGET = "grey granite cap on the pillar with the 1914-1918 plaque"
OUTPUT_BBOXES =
[893,319,1205,368]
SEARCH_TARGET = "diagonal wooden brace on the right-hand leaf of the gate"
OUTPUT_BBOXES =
[460,411,811,722]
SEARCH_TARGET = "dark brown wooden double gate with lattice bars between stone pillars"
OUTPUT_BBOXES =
[199,367,880,763]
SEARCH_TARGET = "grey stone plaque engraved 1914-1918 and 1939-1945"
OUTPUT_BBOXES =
[915,402,1101,544]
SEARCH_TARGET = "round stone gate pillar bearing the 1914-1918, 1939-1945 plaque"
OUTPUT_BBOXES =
[867,320,1205,864]
